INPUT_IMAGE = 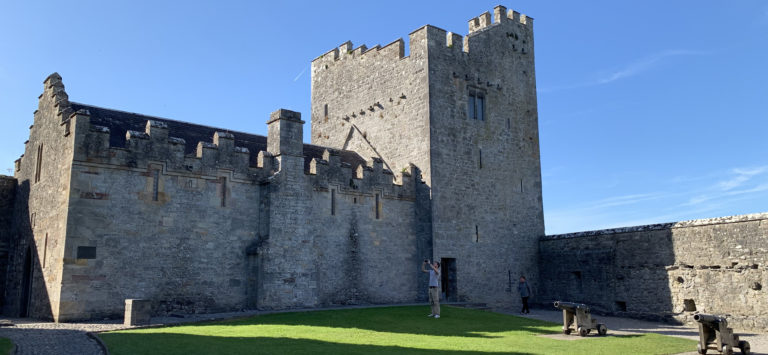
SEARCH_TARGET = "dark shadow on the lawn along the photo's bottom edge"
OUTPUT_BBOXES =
[99,333,527,355]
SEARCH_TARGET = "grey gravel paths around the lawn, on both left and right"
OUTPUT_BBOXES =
[0,305,768,355]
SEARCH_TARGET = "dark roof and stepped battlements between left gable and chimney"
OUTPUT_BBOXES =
[66,103,272,179]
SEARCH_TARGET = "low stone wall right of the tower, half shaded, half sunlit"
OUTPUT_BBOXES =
[536,213,768,330]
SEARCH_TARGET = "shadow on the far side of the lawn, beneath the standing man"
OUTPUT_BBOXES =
[204,306,559,338]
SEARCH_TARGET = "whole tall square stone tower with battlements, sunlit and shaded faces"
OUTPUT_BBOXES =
[312,6,544,304]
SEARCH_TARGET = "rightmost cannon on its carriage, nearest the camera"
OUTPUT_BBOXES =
[693,313,750,355]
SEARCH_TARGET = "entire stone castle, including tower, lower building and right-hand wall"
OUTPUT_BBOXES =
[0,6,768,328]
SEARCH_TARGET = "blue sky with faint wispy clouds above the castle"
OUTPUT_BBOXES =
[0,0,768,234]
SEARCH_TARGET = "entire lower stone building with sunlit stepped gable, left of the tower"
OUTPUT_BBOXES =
[6,74,429,321]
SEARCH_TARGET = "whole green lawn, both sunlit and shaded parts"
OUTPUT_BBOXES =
[99,306,696,355]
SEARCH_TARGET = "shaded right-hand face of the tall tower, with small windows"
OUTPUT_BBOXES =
[427,6,544,306]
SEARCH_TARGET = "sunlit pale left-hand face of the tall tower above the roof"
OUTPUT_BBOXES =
[311,27,430,183]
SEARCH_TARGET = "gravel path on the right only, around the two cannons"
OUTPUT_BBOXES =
[498,309,768,355]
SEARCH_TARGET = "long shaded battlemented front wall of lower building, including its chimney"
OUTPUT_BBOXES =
[36,98,429,321]
